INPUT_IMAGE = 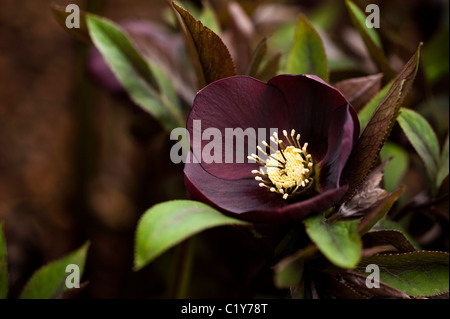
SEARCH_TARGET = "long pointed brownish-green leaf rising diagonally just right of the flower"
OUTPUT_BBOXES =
[342,44,422,202]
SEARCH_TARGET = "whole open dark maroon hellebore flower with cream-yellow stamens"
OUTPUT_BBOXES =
[184,75,359,222]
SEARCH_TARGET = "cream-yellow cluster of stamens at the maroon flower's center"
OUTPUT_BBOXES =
[248,130,314,199]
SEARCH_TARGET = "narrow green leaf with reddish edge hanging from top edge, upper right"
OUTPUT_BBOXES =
[345,0,395,80]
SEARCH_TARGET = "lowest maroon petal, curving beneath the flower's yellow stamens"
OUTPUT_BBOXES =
[184,157,347,222]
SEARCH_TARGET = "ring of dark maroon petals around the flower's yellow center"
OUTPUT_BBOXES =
[185,75,359,222]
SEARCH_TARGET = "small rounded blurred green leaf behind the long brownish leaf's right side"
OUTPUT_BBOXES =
[380,142,409,192]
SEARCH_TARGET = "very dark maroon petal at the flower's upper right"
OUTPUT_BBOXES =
[269,75,359,190]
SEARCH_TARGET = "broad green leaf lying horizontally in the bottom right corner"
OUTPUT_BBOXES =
[355,251,449,297]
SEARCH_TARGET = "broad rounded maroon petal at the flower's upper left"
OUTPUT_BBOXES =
[187,76,289,179]
